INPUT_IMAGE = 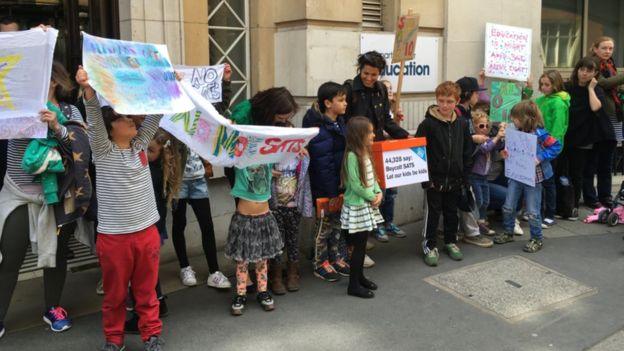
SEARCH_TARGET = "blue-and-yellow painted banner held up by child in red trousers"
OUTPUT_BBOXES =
[82,32,194,115]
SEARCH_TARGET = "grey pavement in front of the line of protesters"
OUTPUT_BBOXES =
[0,199,624,351]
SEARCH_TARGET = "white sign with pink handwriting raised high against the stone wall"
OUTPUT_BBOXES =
[485,23,532,81]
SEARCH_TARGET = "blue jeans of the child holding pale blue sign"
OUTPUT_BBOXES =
[503,179,542,240]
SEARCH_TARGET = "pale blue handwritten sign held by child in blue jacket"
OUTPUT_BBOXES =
[505,128,537,186]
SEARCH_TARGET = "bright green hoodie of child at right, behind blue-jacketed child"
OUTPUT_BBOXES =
[535,91,570,146]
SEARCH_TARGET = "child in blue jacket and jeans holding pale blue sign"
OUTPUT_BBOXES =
[494,100,561,253]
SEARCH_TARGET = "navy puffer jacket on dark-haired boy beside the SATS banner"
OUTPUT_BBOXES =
[302,103,346,200]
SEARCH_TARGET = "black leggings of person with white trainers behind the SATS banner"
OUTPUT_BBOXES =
[171,198,219,273]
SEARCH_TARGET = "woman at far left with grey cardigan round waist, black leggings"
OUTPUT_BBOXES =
[0,62,88,337]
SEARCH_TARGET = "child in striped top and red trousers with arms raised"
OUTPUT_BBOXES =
[76,67,163,351]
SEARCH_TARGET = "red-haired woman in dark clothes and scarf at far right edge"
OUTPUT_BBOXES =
[583,37,624,208]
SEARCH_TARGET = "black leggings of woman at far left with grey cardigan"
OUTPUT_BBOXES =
[0,205,76,322]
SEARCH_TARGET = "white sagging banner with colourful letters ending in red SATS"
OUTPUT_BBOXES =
[160,82,318,168]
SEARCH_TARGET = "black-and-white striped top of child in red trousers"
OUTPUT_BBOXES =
[85,97,162,234]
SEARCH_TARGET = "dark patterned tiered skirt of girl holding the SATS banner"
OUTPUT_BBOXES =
[225,212,284,262]
